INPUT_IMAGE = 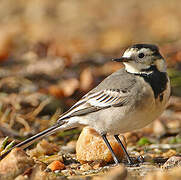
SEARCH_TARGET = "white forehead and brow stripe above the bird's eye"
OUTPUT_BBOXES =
[123,48,152,58]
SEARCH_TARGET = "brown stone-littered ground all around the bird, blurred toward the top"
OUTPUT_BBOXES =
[0,0,181,180]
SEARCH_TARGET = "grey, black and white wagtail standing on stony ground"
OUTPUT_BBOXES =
[1,44,170,164]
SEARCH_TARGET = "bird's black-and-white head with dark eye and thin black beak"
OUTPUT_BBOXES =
[113,44,166,74]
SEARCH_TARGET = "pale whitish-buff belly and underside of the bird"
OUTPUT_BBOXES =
[80,79,170,135]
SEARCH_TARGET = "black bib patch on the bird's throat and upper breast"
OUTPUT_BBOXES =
[135,67,168,101]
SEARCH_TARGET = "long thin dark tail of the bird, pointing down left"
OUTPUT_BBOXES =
[0,121,70,160]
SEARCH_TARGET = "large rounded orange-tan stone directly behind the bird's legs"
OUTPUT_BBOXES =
[76,127,126,164]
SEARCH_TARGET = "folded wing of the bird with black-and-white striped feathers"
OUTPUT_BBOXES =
[58,89,129,121]
